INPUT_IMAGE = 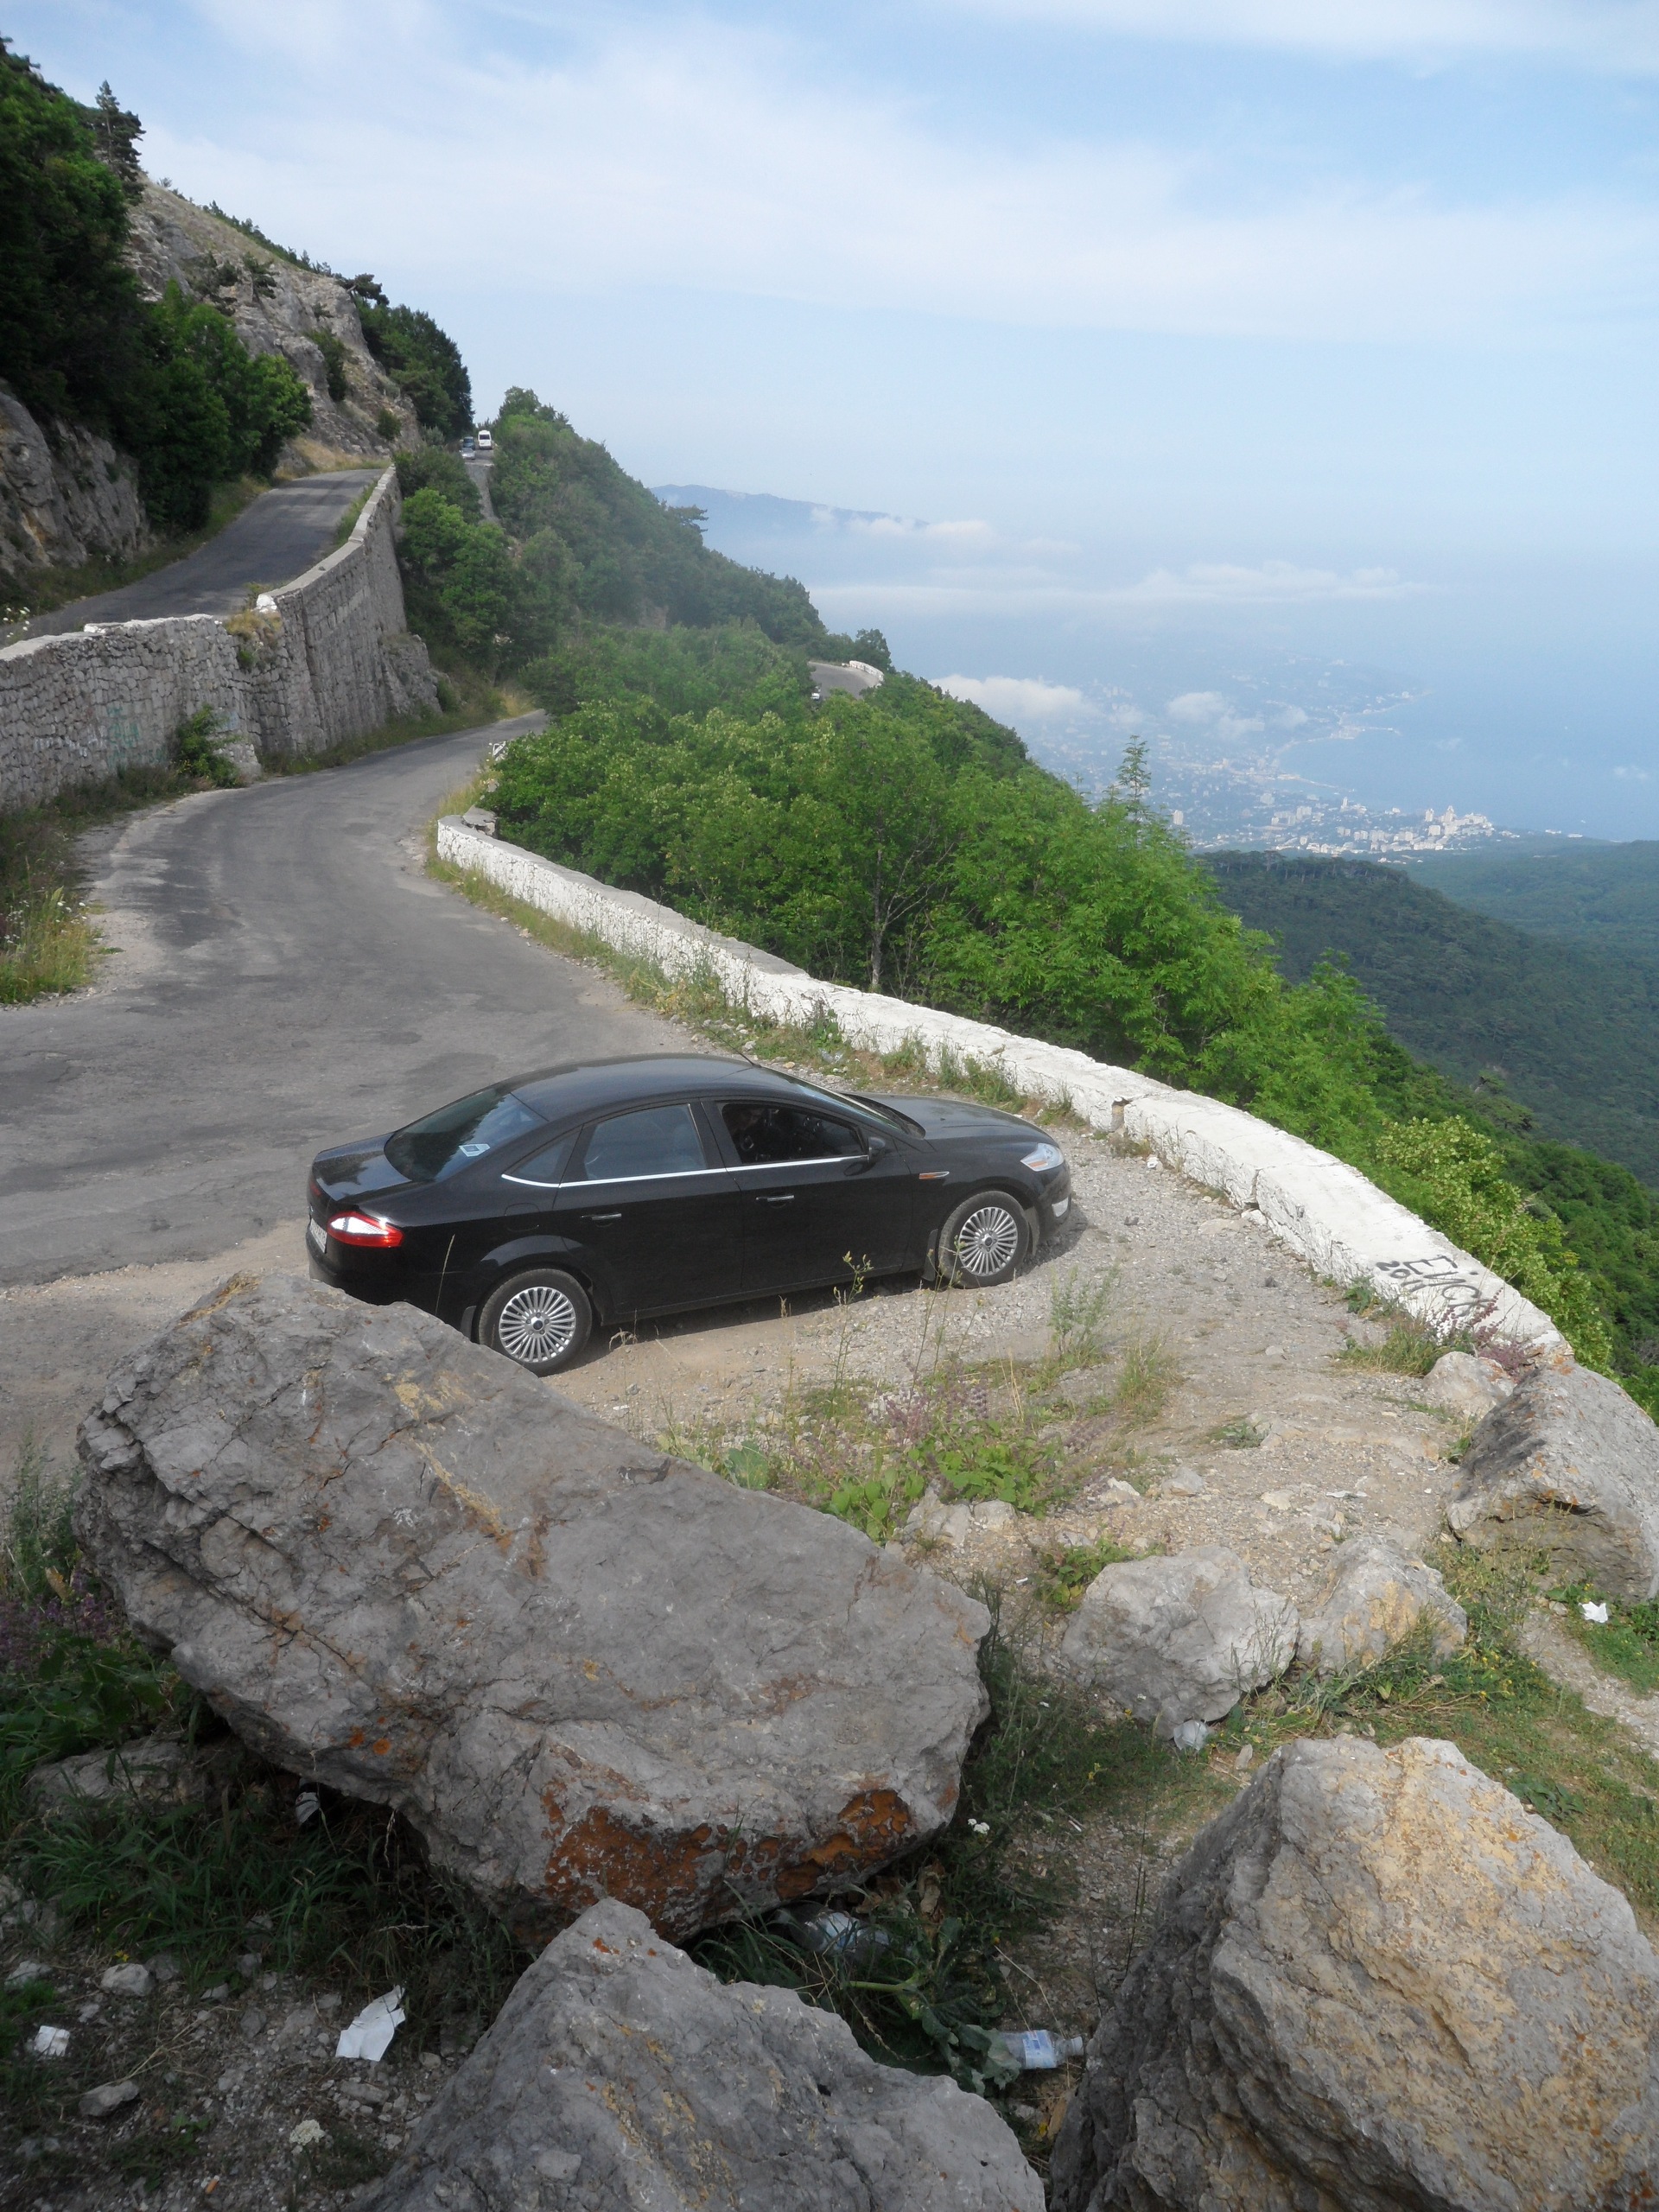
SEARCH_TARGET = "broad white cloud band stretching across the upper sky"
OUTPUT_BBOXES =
[149,0,1659,340]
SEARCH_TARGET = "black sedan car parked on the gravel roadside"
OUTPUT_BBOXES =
[305,1055,1071,1374]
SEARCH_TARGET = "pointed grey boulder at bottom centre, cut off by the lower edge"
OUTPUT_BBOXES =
[360,1903,1042,2212]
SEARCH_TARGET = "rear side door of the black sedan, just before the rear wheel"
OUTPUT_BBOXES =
[553,1099,743,1316]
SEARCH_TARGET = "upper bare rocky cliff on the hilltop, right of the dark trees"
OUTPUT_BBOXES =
[128,183,420,471]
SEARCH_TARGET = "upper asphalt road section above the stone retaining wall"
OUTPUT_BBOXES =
[22,469,380,637]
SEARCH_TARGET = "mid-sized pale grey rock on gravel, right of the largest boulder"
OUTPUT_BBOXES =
[1059,1544,1300,1737]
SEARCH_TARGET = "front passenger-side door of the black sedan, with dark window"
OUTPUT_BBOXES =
[719,1099,912,1292]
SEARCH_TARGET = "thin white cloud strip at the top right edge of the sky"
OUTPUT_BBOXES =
[957,0,1659,71]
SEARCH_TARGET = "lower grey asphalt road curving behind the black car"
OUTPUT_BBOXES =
[0,721,686,1283]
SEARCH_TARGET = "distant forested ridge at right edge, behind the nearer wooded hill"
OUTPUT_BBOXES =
[1414,838,1659,971]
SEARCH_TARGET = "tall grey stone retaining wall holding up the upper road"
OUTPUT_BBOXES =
[0,469,438,810]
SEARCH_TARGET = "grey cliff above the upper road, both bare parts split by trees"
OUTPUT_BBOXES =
[0,183,420,597]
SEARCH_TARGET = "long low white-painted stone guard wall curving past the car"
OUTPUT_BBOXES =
[438,814,1561,1351]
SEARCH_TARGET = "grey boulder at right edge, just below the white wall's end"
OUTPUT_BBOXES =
[1446,1354,1659,1604]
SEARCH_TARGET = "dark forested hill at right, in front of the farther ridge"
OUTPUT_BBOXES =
[1205,852,1659,1188]
